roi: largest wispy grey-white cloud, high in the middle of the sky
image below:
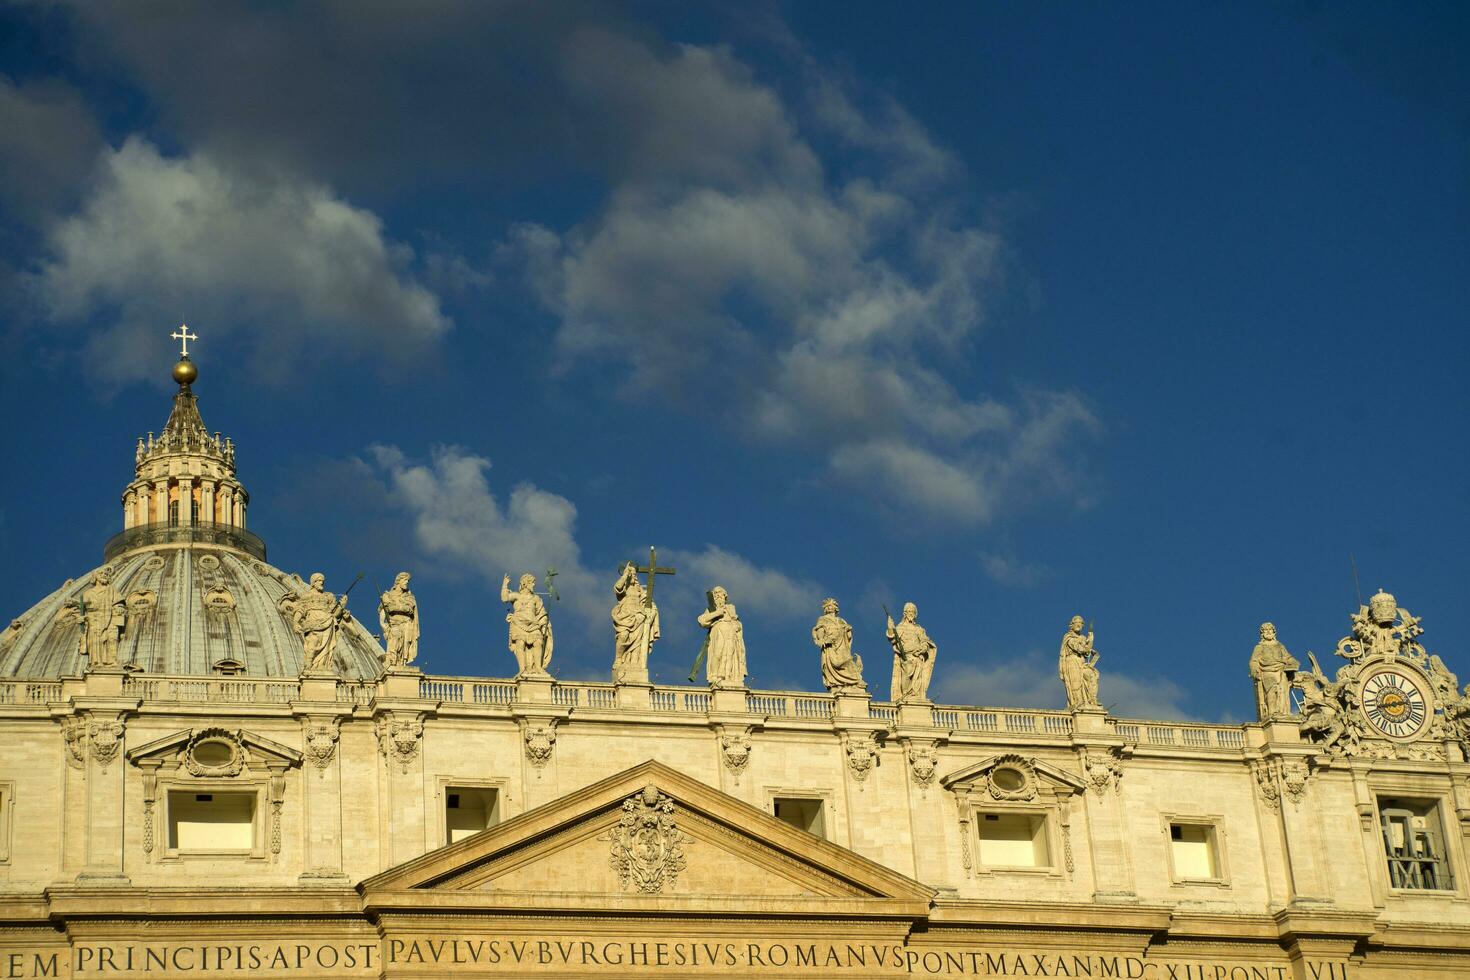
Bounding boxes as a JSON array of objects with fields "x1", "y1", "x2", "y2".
[{"x1": 512, "y1": 32, "x2": 1098, "y2": 523}]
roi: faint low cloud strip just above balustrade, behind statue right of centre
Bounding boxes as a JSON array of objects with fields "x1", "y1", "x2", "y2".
[{"x1": 931, "y1": 652, "x2": 1200, "y2": 721}]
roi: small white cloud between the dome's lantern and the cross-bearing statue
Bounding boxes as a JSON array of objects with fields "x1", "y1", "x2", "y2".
[{"x1": 368, "y1": 445, "x2": 602, "y2": 630}]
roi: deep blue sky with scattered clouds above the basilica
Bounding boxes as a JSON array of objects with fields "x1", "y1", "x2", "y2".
[{"x1": 0, "y1": 3, "x2": 1470, "y2": 720}]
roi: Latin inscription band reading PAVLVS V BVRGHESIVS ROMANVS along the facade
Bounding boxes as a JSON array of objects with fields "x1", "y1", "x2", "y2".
[{"x1": 0, "y1": 937, "x2": 1352, "y2": 980}]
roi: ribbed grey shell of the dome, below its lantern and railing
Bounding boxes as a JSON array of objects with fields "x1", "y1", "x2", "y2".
[{"x1": 0, "y1": 545, "x2": 382, "y2": 680}]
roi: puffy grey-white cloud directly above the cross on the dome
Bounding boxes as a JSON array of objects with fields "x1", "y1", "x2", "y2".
[{"x1": 38, "y1": 137, "x2": 450, "y2": 378}]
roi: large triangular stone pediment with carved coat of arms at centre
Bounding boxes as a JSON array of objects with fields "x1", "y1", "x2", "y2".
[{"x1": 360, "y1": 761, "x2": 935, "y2": 912}]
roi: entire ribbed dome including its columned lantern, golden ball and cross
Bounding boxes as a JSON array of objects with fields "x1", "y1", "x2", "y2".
[{"x1": 0, "y1": 343, "x2": 384, "y2": 680}]
